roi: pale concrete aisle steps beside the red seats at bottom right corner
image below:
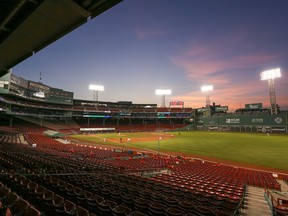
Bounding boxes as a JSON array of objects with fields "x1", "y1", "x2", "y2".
[{"x1": 241, "y1": 186, "x2": 272, "y2": 216}]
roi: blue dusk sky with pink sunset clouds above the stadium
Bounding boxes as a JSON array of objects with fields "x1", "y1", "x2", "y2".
[{"x1": 12, "y1": 0, "x2": 288, "y2": 112}]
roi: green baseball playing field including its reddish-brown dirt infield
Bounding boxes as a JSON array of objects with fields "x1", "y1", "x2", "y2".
[{"x1": 73, "y1": 132, "x2": 288, "y2": 171}]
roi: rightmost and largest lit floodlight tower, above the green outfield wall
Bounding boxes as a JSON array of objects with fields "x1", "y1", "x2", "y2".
[{"x1": 260, "y1": 68, "x2": 281, "y2": 115}]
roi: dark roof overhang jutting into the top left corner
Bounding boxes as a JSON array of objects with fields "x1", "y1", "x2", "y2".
[{"x1": 0, "y1": 0, "x2": 122, "y2": 77}]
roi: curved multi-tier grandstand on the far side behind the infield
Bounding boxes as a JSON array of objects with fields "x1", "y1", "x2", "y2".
[{"x1": 0, "y1": 73, "x2": 194, "y2": 133}]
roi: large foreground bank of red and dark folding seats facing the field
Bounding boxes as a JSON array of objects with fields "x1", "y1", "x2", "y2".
[{"x1": 0, "y1": 131, "x2": 287, "y2": 216}]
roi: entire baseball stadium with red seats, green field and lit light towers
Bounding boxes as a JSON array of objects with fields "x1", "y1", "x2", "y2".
[{"x1": 0, "y1": 0, "x2": 288, "y2": 216}]
